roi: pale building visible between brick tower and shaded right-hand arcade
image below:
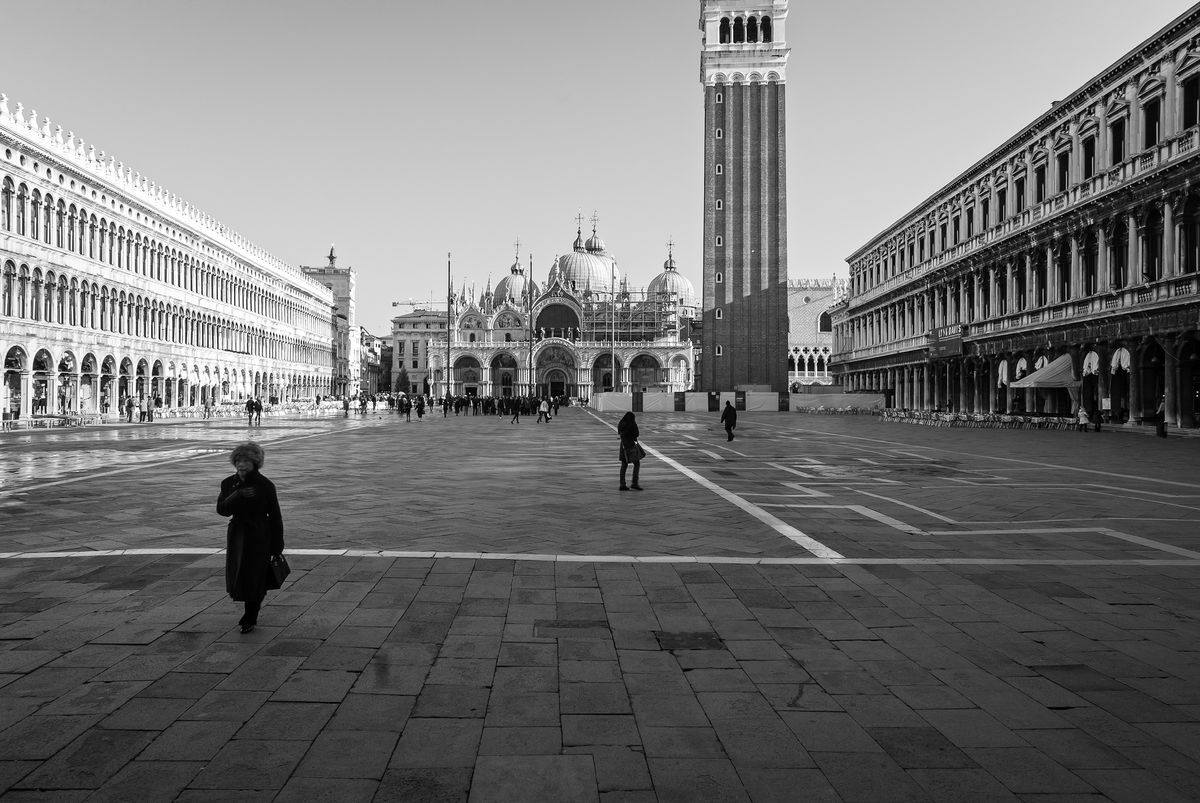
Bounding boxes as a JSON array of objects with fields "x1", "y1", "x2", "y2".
[{"x1": 787, "y1": 278, "x2": 846, "y2": 392}]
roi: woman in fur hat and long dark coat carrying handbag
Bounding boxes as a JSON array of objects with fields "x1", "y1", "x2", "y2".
[{"x1": 217, "y1": 443, "x2": 283, "y2": 633}]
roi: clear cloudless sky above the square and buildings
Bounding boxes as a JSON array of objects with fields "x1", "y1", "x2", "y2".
[{"x1": 0, "y1": 0, "x2": 1190, "y2": 335}]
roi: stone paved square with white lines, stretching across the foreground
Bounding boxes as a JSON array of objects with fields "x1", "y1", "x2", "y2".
[{"x1": 0, "y1": 408, "x2": 1200, "y2": 801}]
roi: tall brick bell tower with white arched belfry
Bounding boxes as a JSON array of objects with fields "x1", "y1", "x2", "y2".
[{"x1": 700, "y1": 0, "x2": 791, "y2": 391}]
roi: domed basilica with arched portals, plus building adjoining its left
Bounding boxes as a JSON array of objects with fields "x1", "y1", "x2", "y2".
[{"x1": 392, "y1": 224, "x2": 696, "y2": 397}]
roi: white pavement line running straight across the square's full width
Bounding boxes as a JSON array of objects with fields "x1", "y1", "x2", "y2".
[{"x1": 0, "y1": 547, "x2": 1200, "y2": 569}]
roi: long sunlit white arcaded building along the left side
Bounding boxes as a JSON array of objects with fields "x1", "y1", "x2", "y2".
[{"x1": 0, "y1": 95, "x2": 332, "y2": 418}]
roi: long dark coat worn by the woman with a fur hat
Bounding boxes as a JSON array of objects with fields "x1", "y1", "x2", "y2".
[{"x1": 217, "y1": 472, "x2": 283, "y2": 603}]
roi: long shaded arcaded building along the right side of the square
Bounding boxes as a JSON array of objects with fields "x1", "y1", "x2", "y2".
[{"x1": 834, "y1": 8, "x2": 1200, "y2": 427}]
